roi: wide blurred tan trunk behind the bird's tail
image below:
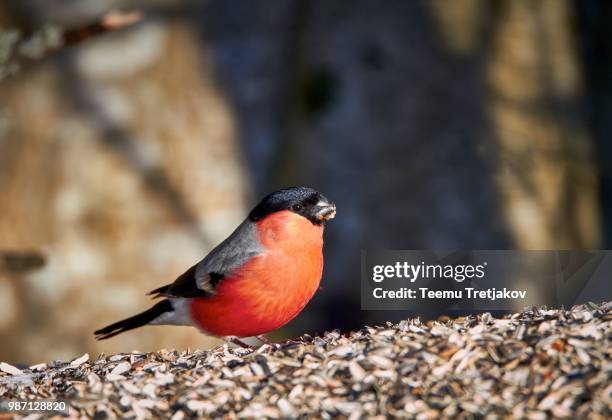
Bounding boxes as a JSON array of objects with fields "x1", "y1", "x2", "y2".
[{"x1": 0, "y1": 1, "x2": 249, "y2": 363}]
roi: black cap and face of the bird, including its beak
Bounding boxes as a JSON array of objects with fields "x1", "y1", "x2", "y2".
[{"x1": 249, "y1": 187, "x2": 336, "y2": 225}]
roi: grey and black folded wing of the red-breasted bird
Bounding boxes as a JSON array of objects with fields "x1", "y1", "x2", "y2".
[{"x1": 149, "y1": 219, "x2": 263, "y2": 298}]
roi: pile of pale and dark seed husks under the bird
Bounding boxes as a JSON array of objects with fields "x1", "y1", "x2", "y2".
[{"x1": 0, "y1": 303, "x2": 612, "y2": 419}]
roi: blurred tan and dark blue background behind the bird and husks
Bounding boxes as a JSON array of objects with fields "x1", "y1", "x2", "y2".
[{"x1": 0, "y1": 0, "x2": 612, "y2": 363}]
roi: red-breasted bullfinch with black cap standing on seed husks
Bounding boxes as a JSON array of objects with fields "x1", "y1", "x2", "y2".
[{"x1": 94, "y1": 187, "x2": 336, "y2": 347}]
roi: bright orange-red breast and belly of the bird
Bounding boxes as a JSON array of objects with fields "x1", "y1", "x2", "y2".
[{"x1": 191, "y1": 211, "x2": 323, "y2": 337}]
